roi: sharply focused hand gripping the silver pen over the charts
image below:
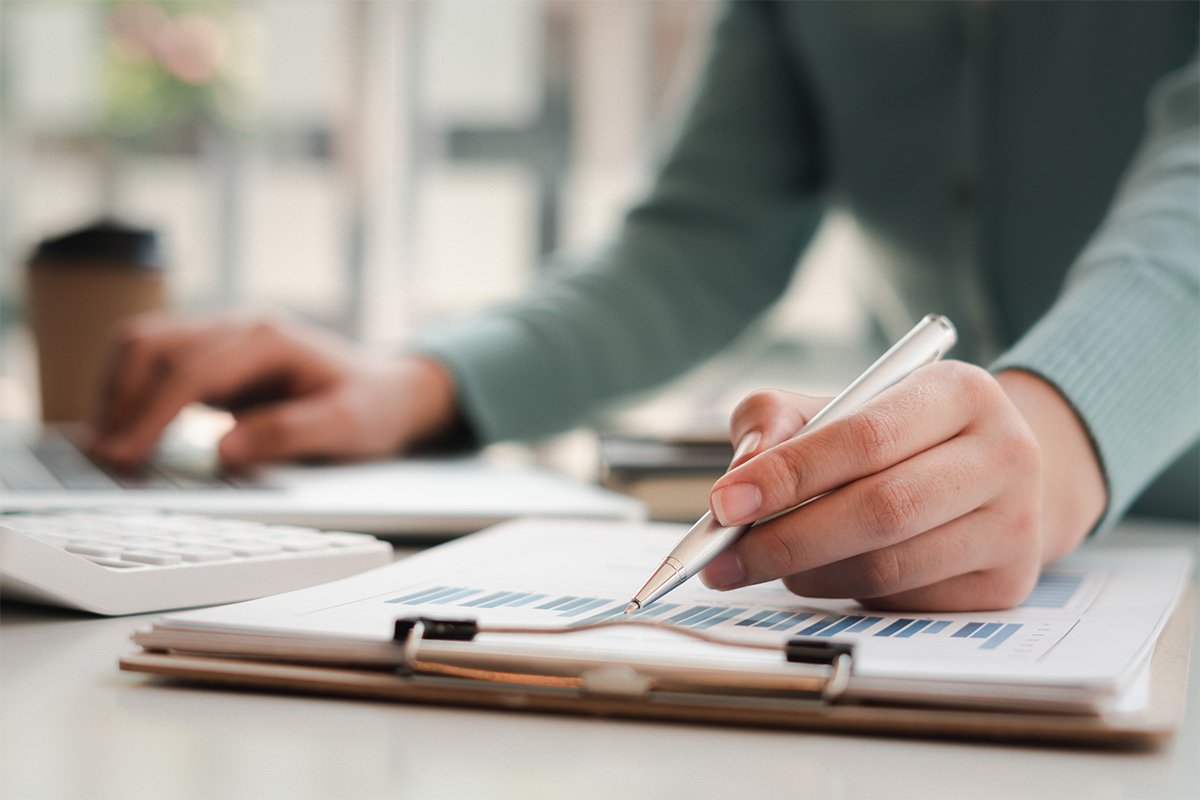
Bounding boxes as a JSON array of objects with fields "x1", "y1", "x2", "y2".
[{"x1": 702, "y1": 361, "x2": 1106, "y2": 610}]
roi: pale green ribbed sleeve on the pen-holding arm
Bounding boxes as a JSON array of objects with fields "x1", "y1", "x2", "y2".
[{"x1": 992, "y1": 53, "x2": 1200, "y2": 530}]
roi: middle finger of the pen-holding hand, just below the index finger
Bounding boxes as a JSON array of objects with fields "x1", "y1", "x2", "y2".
[{"x1": 706, "y1": 437, "x2": 1010, "y2": 596}]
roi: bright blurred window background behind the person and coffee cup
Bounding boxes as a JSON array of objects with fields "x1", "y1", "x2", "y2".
[{"x1": 0, "y1": 0, "x2": 865, "y2": 424}]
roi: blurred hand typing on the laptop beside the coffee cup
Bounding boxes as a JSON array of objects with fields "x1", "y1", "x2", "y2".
[{"x1": 91, "y1": 315, "x2": 457, "y2": 467}]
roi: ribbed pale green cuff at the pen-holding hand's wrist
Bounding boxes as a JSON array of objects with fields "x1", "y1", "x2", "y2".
[{"x1": 991, "y1": 259, "x2": 1200, "y2": 534}]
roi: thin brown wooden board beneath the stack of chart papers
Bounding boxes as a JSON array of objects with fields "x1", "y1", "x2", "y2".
[{"x1": 120, "y1": 588, "x2": 1195, "y2": 748}]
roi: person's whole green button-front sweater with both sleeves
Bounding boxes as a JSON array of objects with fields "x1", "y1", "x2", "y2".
[{"x1": 419, "y1": 0, "x2": 1200, "y2": 532}]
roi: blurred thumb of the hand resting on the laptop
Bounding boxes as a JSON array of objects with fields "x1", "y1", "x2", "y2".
[{"x1": 220, "y1": 392, "x2": 357, "y2": 467}]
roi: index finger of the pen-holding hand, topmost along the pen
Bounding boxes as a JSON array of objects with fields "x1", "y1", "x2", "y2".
[{"x1": 709, "y1": 362, "x2": 1007, "y2": 525}]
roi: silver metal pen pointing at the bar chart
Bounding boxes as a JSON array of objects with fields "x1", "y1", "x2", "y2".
[{"x1": 625, "y1": 314, "x2": 958, "y2": 614}]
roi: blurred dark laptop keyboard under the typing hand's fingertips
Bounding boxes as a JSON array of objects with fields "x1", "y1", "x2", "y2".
[{"x1": 0, "y1": 428, "x2": 244, "y2": 492}]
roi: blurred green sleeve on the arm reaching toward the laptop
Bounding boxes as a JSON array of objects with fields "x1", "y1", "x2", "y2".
[{"x1": 416, "y1": 1, "x2": 820, "y2": 443}]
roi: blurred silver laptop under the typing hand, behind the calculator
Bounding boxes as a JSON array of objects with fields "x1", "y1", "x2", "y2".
[{"x1": 0, "y1": 422, "x2": 644, "y2": 539}]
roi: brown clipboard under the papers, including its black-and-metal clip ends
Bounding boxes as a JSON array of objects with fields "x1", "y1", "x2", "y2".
[{"x1": 120, "y1": 587, "x2": 1195, "y2": 748}]
